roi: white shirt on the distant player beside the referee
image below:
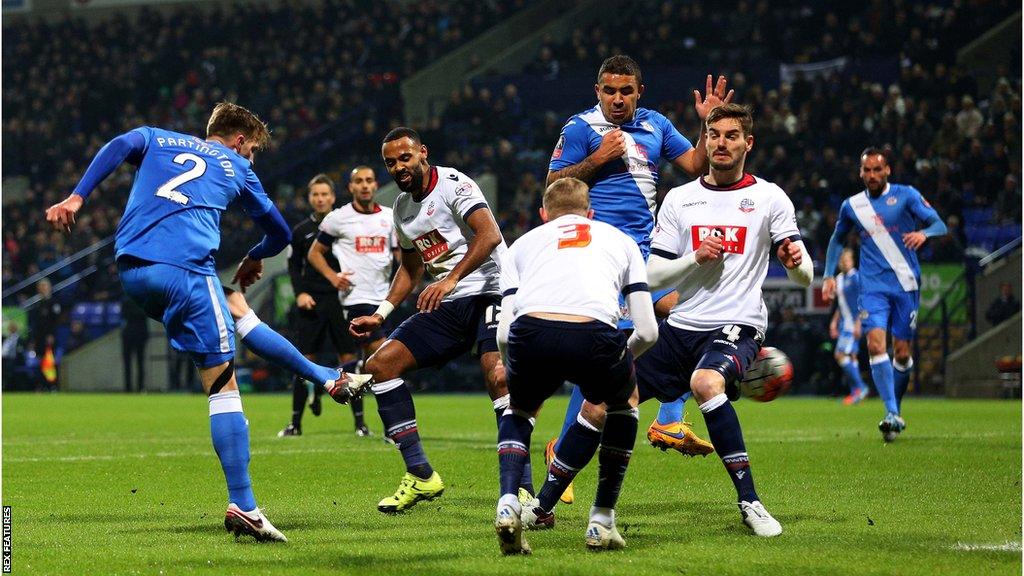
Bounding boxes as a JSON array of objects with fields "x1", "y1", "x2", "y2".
[{"x1": 317, "y1": 203, "x2": 398, "y2": 306}]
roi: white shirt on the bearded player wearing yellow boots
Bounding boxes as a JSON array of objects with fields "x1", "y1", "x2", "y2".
[{"x1": 394, "y1": 166, "x2": 506, "y2": 301}]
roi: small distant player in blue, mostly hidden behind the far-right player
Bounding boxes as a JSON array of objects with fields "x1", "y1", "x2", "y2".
[{"x1": 828, "y1": 248, "x2": 867, "y2": 406}]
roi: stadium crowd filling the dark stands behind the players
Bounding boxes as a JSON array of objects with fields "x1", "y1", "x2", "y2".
[{"x1": 2, "y1": 0, "x2": 1021, "y2": 373}]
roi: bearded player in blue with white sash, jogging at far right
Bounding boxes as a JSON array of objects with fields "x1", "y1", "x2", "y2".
[{"x1": 821, "y1": 148, "x2": 946, "y2": 442}]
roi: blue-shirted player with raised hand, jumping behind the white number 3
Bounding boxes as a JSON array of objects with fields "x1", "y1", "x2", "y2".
[{"x1": 547, "y1": 55, "x2": 733, "y2": 503}]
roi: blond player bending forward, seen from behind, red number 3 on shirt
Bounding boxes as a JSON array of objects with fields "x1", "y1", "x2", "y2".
[{"x1": 495, "y1": 177, "x2": 657, "y2": 554}]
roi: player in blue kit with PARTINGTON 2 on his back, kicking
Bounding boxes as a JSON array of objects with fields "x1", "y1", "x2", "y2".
[{"x1": 46, "y1": 102, "x2": 370, "y2": 541}]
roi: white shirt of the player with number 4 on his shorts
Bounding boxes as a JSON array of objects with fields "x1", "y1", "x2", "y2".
[{"x1": 651, "y1": 174, "x2": 800, "y2": 332}]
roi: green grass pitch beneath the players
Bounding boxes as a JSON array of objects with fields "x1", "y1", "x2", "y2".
[{"x1": 3, "y1": 394, "x2": 1021, "y2": 576}]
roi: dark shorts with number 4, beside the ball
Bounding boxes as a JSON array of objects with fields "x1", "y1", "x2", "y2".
[{"x1": 636, "y1": 322, "x2": 761, "y2": 402}]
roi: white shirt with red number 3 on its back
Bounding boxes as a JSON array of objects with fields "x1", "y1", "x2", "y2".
[{"x1": 501, "y1": 214, "x2": 647, "y2": 327}]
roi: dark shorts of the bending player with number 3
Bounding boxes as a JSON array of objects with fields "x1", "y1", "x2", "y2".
[{"x1": 505, "y1": 316, "x2": 636, "y2": 412}]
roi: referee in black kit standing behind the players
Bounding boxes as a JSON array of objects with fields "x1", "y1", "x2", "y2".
[{"x1": 278, "y1": 174, "x2": 370, "y2": 438}]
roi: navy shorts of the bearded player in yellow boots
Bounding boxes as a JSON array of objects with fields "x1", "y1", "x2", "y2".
[{"x1": 390, "y1": 294, "x2": 502, "y2": 368}]
